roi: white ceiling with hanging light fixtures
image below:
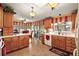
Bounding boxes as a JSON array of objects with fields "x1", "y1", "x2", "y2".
[{"x1": 3, "y1": 3, "x2": 78, "y2": 21}]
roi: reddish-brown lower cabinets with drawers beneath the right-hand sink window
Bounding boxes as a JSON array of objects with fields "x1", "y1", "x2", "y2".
[{"x1": 52, "y1": 35, "x2": 76, "y2": 53}]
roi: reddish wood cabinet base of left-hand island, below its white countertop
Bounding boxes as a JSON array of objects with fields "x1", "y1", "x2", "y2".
[{"x1": 3, "y1": 35, "x2": 29, "y2": 53}]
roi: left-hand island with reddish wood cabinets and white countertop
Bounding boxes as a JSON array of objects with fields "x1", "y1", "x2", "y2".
[{"x1": 0, "y1": 33, "x2": 31, "y2": 55}]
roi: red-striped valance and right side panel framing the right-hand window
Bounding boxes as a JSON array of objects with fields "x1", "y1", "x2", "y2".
[{"x1": 52, "y1": 13, "x2": 77, "y2": 31}]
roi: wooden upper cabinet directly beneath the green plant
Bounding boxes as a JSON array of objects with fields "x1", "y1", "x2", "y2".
[{"x1": 3, "y1": 12, "x2": 13, "y2": 27}]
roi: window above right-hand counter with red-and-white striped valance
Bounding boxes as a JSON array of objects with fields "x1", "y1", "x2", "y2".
[{"x1": 54, "y1": 14, "x2": 76, "y2": 31}]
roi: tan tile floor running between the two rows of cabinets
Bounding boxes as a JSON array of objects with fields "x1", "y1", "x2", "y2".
[{"x1": 7, "y1": 40, "x2": 58, "y2": 56}]
